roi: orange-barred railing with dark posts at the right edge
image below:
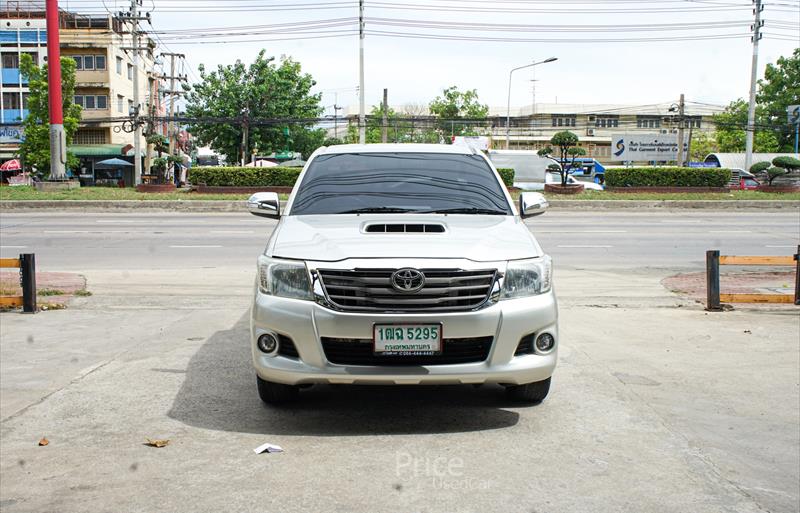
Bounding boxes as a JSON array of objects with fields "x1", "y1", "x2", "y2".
[{"x1": 706, "y1": 246, "x2": 800, "y2": 312}]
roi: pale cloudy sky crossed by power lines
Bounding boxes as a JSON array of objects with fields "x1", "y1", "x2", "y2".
[{"x1": 54, "y1": 0, "x2": 800, "y2": 114}]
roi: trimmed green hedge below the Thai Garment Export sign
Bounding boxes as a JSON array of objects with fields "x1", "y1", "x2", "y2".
[{"x1": 606, "y1": 167, "x2": 731, "y2": 187}]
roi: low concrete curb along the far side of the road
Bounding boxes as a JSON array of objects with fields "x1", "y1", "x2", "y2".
[{"x1": 0, "y1": 199, "x2": 800, "y2": 212}]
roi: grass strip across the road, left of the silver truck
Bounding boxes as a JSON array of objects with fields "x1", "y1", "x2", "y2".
[{"x1": 0, "y1": 186, "x2": 289, "y2": 201}]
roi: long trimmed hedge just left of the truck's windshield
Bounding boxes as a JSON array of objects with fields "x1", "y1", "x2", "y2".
[{"x1": 189, "y1": 167, "x2": 302, "y2": 187}]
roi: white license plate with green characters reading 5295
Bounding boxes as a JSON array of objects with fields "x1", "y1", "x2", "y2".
[{"x1": 372, "y1": 324, "x2": 442, "y2": 356}]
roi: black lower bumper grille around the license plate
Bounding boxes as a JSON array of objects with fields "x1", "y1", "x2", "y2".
[{"x1": 322, "y1": 336, "x2": 494, "y2": 366}]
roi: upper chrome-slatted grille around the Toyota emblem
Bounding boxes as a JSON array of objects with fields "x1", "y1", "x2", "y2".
[{"x1": 317, "y1": 269, "x2": 497, "y2": 312}]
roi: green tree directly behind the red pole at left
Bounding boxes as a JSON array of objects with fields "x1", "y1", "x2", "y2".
[{"x1": 19, "y1": 53, "x2": 81, "y2": 178}]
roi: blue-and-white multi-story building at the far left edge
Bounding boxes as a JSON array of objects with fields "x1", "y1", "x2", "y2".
[{"x1": 0, "y1": 12, "x2": 47, "y2": 162}]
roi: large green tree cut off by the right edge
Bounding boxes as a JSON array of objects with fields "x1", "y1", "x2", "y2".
[{"x1": 756, "y1": 48, "x2": 800, "y2": 153}]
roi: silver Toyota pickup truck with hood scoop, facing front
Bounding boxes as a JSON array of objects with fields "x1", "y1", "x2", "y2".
[{"x1": 247, "y1": 144, "x2": 558, "y2": 403}]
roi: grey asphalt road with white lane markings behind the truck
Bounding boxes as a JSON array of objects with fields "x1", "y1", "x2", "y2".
[{"x1": 0, "y1": 210, "x2": 800, "y2": 270}]
